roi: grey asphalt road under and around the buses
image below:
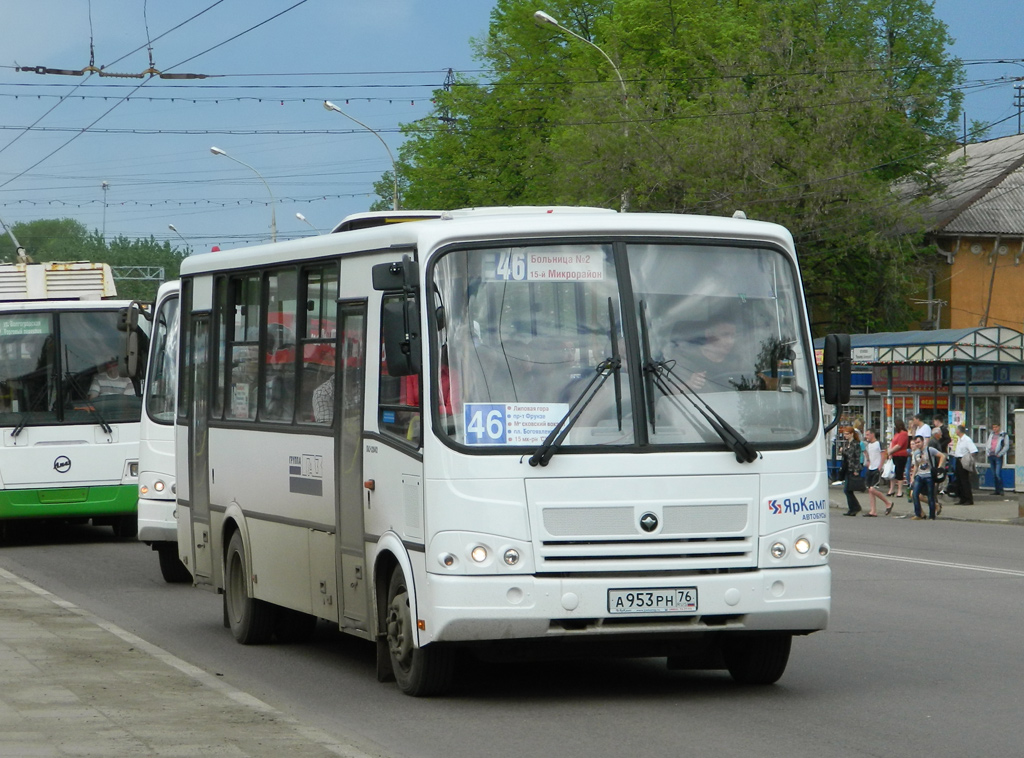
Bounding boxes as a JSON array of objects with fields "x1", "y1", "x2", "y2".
[{"x1": 0, "y1": 518, "x2": 1024, "y2": 758}]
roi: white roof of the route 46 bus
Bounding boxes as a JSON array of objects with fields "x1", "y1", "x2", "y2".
[{"x1": 181, "y1": 208, "x2": 794, "y2": 277}]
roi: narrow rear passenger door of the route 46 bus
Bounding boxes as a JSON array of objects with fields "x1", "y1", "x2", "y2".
[{"x1": 188, "y1": 313, "x2": 213, "y2": 585}]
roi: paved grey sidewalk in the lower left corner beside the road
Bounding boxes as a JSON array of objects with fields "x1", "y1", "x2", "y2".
[{"x1": 0, "y1": 569, "x2": 369, "y2": 758}]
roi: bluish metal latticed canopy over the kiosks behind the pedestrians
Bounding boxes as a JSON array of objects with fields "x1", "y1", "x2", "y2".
[{"x1": 814, "y1": 327, "x2": 1024, "y2": 366}]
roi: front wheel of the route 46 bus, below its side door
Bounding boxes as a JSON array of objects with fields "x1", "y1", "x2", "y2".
[{"x1": 385, "y1": 569, "x2": 455, "y2": 698}]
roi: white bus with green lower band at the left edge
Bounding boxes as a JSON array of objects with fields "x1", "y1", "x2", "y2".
[{"x1": 0, "y1": 263, "x2": 144, "y2": 538}]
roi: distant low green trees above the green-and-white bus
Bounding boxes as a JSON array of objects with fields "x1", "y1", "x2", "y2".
[{"x1": 0, "y1": 218, "x2": 186, "y2": 302}]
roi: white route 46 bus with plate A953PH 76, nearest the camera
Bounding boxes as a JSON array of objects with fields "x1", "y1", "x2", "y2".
[{"x1": 176, "y1": 208, "x2": 840, "y2": 696}]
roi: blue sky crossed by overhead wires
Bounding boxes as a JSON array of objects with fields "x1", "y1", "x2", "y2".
[{"x1": 0, "y1": 0, "x2": 1024, "y2": 253}]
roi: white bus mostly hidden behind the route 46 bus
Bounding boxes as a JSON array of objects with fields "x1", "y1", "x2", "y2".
[{"x1": 138, "y1": 282, "x2": 191, "y2": 583}]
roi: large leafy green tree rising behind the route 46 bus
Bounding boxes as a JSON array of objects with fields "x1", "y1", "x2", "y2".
[{"x1": 381, "y1": 0, "x2": 963, "y2": 331}]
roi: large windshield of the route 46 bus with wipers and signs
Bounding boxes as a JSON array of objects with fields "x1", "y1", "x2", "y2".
[{"x1": 432, "y1": 240, "x2": 816, "y2": 449}]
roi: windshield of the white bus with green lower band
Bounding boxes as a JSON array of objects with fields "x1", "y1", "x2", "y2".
[{"x1": 0, "y1": 309, "x2": 141, "y2": 430}]
